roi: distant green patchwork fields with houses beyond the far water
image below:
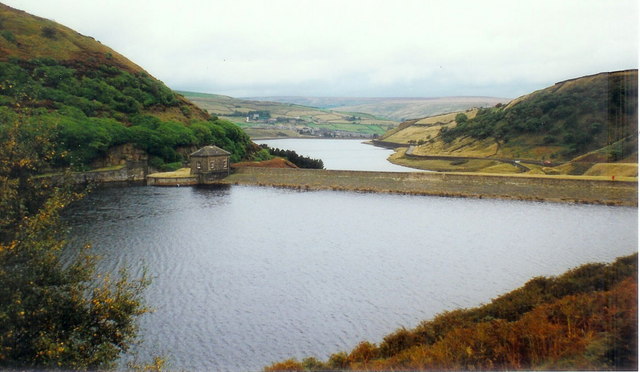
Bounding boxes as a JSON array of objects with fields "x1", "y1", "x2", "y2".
[{"x1": 178, "y1": 91, "x2": 398, "y2": 138}]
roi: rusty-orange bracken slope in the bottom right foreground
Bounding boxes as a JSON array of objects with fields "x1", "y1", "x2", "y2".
[{"x1": 265, "y1": 254, "x2": 638, "y2": 371}]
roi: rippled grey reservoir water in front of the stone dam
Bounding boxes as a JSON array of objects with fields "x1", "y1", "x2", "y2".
[{"x1": 61, "y1": 139, "x2": 638, "y2": 371}]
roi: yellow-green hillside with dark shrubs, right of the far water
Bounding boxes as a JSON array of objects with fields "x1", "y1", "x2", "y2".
[{"x1": 381, "y1": 70, "x2": 638, "y2": 177}]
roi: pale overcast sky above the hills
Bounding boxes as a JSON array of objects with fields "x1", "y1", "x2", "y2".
[{"x1": 5, "y1": 0, "x2": 638, "y2": 98}]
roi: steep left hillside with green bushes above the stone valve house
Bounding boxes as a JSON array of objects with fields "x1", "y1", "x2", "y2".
[{"x1": 0, "y1": 4, "x2": 256, "y2": 171}]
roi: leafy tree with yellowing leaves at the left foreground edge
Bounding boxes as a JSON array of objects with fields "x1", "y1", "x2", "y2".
[{"x1": 0, "y1": 110, "x2": 148, "y2": 369}]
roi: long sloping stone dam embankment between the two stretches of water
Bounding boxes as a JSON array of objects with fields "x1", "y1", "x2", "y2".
[{"x1": 219, "y1": 168, "x2": 638, "y2": 206}]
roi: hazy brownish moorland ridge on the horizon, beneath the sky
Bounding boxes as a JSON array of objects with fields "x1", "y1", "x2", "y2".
[{"x1": 242, "y1": 97, "x2": 509, "y2": 121}]
